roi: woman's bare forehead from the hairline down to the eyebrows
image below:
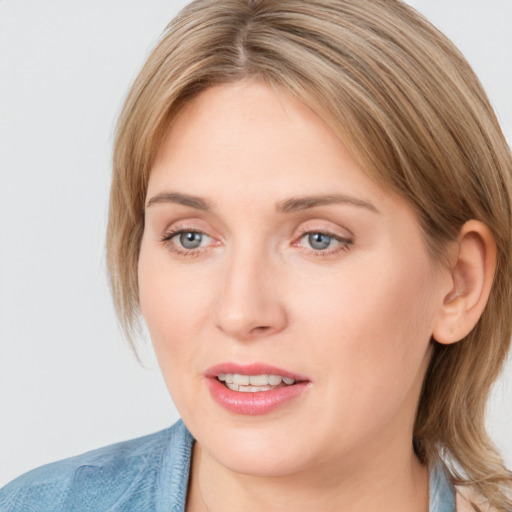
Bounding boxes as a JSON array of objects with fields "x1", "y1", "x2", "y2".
[{"x1": 148, "y1": 80, "x2": 396, "y2": 208}]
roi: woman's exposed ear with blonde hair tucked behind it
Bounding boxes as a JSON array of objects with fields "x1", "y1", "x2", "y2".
[{"x1": 432, "y1": 220, "x2": 496, "y2": 345}]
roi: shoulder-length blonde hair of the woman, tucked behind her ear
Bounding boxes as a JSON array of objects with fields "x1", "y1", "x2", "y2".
[{"x1": 107, "y1": 0, "x2": 512, "y2": 511}]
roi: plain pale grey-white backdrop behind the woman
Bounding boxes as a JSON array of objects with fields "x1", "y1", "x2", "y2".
[{"x1": 0, "y1": 0, "x2": 512, "y2": 486}]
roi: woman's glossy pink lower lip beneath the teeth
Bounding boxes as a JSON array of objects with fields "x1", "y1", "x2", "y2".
[{"x1": 206, "y1": 378, "x2": 309, "y2": 416}]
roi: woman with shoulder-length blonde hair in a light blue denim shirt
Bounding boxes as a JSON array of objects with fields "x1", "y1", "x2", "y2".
[{"x1": 0, "y1": 0, "x2": 512, "y2": 512}]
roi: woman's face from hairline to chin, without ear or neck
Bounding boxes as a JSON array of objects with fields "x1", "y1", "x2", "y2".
[{"x1": 139, "y1": 81, "x2": 447, "y2": 476}]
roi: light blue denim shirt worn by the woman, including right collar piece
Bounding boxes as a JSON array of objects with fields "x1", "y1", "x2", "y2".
[{"x1": 0, "y1": 421, "x2": 455, "y2": 512}]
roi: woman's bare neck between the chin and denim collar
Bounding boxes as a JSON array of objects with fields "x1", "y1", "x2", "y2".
[{"x1": 187, "y1": 436, "x2": 429, "y2": 512}]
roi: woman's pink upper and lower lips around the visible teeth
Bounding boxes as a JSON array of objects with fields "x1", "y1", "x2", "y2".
[{"x1": 205, "y1": 363, "x2": 311, "y2": 416}]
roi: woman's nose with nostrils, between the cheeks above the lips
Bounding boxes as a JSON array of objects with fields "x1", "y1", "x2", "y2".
[{"x1": 215, "y1": 248, "x2": 288, "y2": 340}]
